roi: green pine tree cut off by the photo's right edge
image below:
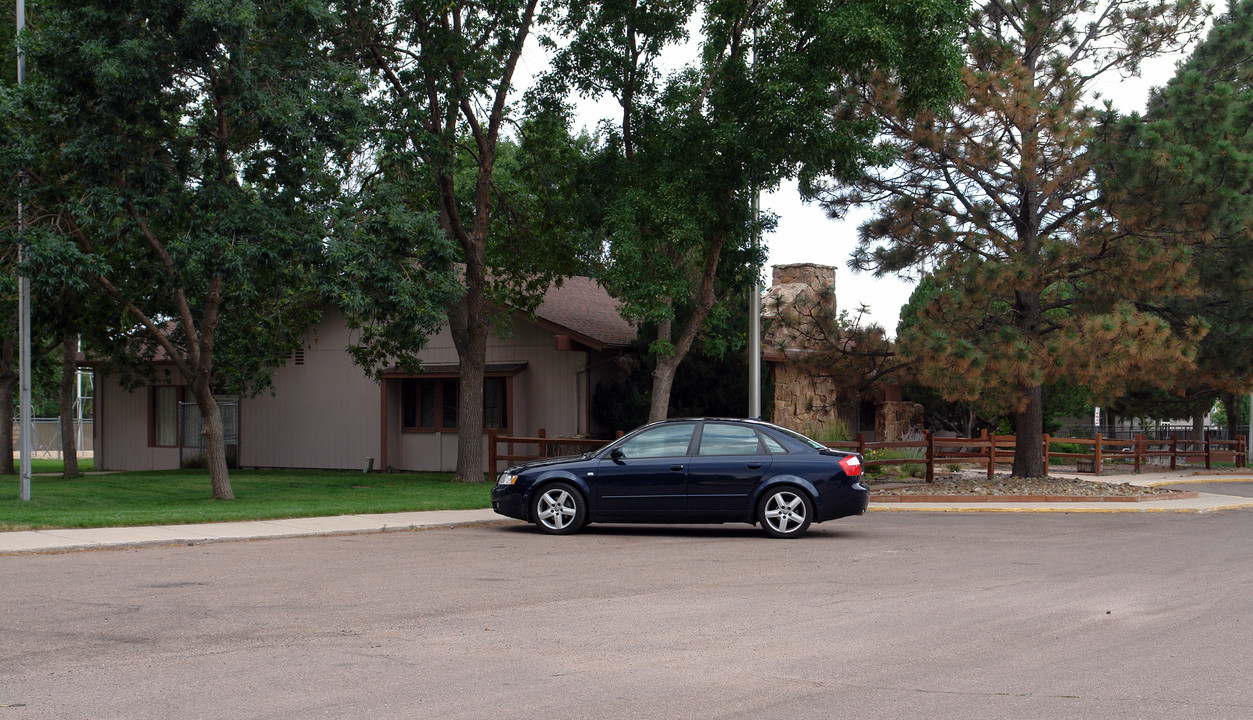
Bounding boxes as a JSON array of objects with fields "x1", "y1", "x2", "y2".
[{"x1": 1095, "y1": 0, "x2": 1253, "y2": 416}]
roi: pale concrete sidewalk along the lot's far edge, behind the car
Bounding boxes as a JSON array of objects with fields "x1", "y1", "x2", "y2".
[{"x1": 0, "y1": 472, "x2": 1253, "y2": 555}]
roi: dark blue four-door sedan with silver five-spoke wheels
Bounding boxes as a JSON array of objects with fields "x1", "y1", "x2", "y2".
[{"x1": 491, "y1": 418, "x2": 870, "y2": 537}]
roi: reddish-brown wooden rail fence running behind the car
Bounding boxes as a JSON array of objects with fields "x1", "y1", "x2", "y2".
[{"x1": 487, "y1": 428, "x2": 1248, "y2": 482}]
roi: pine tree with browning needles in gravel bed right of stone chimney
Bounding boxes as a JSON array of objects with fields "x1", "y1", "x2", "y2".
[{"x1": 809, "y1": 0, "x2": 1204, "y2": 477}]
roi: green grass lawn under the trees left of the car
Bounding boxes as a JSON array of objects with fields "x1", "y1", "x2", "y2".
[{"x1": 0, "y1": 470, "x2": 491, "y2": 531}]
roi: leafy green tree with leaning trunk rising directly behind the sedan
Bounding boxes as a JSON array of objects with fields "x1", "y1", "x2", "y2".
[{"x1": 540, "y1": 0, "x2": 962, "y2": 418}]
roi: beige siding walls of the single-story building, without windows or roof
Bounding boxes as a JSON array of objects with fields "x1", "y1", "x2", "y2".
[{"x1": 98, "y1": 311, "x2": 588, "y2": 471}]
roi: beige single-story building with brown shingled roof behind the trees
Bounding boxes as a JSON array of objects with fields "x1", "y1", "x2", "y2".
[{"x1": 87, "y1": 277, "x2": 635, "y2": 471}]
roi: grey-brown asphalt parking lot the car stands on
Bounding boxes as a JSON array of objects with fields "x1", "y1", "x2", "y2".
[{"x1": 0, "y1": 510, "x2": 1253, "y2": 720}]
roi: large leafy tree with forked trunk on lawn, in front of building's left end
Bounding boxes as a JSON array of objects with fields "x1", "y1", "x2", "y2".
[{"x1": 4, "y1": 0, "x2": 362, "y2": 500}]
